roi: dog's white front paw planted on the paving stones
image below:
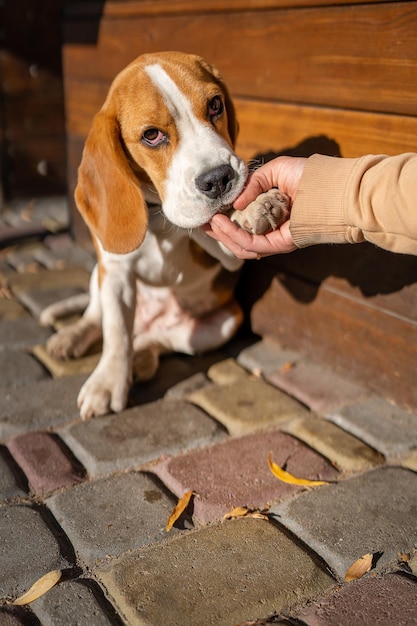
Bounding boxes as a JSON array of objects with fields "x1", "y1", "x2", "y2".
[{"x1": 78, "y1": 367, "x2": 130, "y2": 420}]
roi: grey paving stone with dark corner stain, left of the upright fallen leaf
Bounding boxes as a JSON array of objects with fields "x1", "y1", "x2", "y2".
[{"x1": 46, "y1": 472, "x2": 180, "y2": 565}]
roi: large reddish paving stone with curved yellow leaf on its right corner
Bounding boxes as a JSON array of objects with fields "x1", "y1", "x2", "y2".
[{"x1": 150, "y1": 431, "x2": 339, "y2": 523}]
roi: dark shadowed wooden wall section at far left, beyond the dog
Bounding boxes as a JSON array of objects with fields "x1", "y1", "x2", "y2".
[{"x1": 0, "y1": 0, "x2": 86, "y2": 199}]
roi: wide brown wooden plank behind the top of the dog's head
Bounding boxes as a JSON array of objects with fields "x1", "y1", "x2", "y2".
[{"x1": 65, "y1": 2, "x2": 417, "y2": 115}]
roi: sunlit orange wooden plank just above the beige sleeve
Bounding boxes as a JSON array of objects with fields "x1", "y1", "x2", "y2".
[{"x1": 234, "y1": 98, "x2": 417, "y2": 159}]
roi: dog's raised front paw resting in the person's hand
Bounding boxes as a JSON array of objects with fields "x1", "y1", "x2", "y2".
[{"x1": 230, "y1": 189, "x2": 290, "y2": 235}]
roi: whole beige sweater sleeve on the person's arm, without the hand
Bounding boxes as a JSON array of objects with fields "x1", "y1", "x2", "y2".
[{"x1": 290, "y1": 153, "x2": 417, "y2": 255}]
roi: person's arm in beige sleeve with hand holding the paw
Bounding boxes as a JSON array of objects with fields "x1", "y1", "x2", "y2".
[{"x1": 203, "y1": 153, "x2": 417, "y2": 259}]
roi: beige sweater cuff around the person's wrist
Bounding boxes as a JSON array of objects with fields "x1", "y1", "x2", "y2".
[{"x1": 290, "y1": 154, "x2": 361, "y2": 248}]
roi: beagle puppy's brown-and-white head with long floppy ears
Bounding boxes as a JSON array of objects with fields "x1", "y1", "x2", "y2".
[{"x1": 75, "y1": 52, "x2": 247, "y2": 254}]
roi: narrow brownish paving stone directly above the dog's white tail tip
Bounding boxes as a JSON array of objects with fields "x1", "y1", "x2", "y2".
[{"x1": 9, "y1": 268, "x2": 90, "y2": 296}]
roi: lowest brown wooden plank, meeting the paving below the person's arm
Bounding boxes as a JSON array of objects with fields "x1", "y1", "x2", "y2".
[{"x1": 252, "y1": 275, "x2": 417, "y2": 410}]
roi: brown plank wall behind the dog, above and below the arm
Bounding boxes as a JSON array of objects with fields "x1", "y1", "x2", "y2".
[{"x1": 63, "y1": 0, "x2": 417, "y2": 408}]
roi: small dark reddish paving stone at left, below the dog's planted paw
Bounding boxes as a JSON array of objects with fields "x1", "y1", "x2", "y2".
[{"x1": 7, "y1": 432, "x2": 83, "y2": 496}]
